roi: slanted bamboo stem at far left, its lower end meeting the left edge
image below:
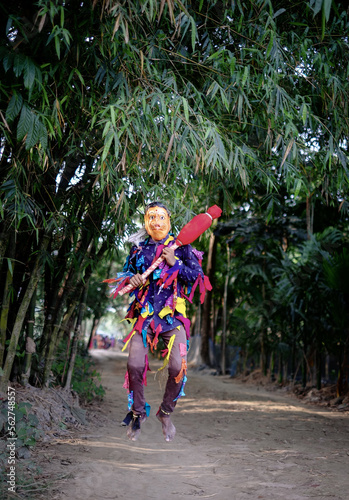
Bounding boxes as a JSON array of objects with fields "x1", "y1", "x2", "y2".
[{"x1": 1, "y1": 234, "x2": 51, "y2": 391}]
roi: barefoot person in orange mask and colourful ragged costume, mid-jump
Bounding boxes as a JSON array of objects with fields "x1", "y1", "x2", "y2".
[{"x1": 110, "y1": 202, "x2": 211, "y2": 441}]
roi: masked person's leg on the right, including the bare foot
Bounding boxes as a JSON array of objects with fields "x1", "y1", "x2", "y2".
[{"x1": 157, "y1": 327, "x2": 187, "y2": 441}]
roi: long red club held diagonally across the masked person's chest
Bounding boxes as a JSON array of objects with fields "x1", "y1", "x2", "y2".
[{"x1": 119, "y1": 205, "x2": 222, "y2": 295}]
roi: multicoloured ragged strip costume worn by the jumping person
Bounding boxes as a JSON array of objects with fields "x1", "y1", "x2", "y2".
[{"x1": 110, "y1": 233, "x2": 211, "y2": 425}]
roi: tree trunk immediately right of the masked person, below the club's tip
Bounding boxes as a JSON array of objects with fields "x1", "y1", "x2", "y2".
[{"x1": 200, "y1": 233, "x2": 217, "y2": 366}]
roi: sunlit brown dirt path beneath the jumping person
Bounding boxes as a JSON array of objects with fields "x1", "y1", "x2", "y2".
[{"x1": 42, "y1": 351, "x2": 349, "y2": 500}]
